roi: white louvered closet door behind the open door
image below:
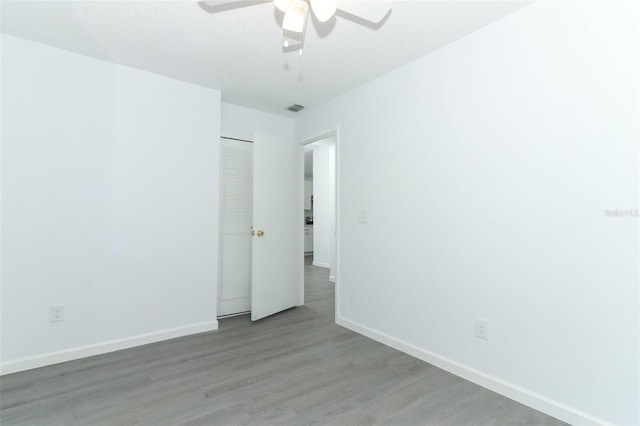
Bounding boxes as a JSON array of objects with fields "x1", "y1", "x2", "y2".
[{"x1": 218, "y1": 139, "x2": 253, "y2": 316}]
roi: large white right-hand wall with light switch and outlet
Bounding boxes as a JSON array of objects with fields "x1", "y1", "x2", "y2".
[{"x1": 296, "y1": 2, "x2": 640, "y2": 425}]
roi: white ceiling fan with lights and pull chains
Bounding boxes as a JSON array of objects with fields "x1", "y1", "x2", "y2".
[{"x1": 201, "y1": 0, "x2": 391, "y2": 55}]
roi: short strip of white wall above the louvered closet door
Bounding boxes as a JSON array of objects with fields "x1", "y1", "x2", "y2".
[{"x1": 220, "y1": 102, "x2": 295, "y2": 141}]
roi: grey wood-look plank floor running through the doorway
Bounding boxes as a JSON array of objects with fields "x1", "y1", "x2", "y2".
[{"x1": 0, "y1": 262, "x2": 564, "y2": 426}]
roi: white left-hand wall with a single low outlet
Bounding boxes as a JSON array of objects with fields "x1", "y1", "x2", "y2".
[{"x1": 1, "y1": 35, "x2": 220, "y2": 372}]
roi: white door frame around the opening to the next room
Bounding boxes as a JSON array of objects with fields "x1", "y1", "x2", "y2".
[{"x1": 298, "y1": 125, "x2": 341, "y2": 320}]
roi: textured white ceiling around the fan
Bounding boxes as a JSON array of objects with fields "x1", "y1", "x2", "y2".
[{"x1": 1, "y1": 0, "x2": 527, "y2": 115}]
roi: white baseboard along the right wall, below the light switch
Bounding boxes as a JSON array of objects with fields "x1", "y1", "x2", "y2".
[{"x1": 336, "y1": 317, "x2": 610, "y2": 425}]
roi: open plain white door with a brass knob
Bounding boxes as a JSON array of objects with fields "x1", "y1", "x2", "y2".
[{"x1": 251, "y1": 132, "x2": 302, "y2": 321}]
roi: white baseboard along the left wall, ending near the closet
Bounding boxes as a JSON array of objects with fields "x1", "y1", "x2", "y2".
[{"x1": 0, "y1": 320, "x2": 218, "y2": 375}]
